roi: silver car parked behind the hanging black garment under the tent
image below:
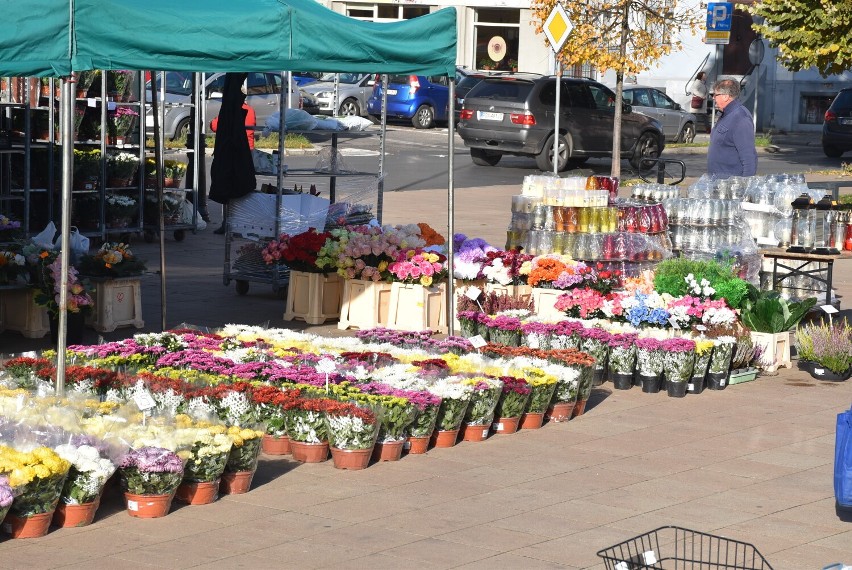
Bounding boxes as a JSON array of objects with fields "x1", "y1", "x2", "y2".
[{"x1": 145, "y1": 71, "x2": 302, "y2": 139}]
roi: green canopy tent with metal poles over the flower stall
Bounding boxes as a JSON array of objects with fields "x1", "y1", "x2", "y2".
[{"x1": 0, "y1": 0, "x2": 456, "y2": 392}]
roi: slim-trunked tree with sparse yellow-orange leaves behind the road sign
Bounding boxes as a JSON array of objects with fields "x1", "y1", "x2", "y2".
[{"x1": 531, "y1": 0, "x2": 704, "y2": 176}]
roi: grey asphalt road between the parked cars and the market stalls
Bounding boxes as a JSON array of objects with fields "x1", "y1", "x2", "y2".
[{"x1": 276, "y1": 125, "x2": 843, "y2": 191}]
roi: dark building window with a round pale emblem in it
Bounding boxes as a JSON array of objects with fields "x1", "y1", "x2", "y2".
[{"x1": 474, "y1": 8, "x2": 521, "y2": 71}]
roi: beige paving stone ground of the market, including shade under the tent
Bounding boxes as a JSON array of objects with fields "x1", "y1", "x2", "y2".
[{"x1": 0, "y1": 174, "x2": 852, "y2": 570}]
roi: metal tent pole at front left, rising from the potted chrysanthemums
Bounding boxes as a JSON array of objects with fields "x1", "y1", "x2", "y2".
[{"x1": 56, "y1": 77, "x2": 76, "y2": 396}]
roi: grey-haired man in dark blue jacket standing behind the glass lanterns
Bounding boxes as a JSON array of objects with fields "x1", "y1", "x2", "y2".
[{"x1": 707, "y1": 79, "x2": 757, "y2": 178}]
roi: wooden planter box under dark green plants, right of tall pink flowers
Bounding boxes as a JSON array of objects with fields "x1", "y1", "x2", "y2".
[{"x1": 86, "y1": 277, "x2": 145, "y2": 332}]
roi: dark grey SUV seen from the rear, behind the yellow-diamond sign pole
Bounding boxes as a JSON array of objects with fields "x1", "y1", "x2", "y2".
[{"x1": 458, "y1": 74, "x2": 665, "y2": 171}]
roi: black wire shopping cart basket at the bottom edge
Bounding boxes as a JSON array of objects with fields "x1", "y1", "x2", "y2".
[{"x1": 598, "y1": 526, "x2": 772, "y2": 570}]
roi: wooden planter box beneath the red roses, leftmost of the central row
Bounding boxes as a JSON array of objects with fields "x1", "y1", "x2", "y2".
[{"x1": 284, "y1": 271, "x2": 343, "y2": 325}]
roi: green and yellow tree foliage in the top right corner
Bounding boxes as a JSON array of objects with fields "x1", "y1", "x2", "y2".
[{"x1": 751, "y1": 0, "x2": 852, "y2": 77}]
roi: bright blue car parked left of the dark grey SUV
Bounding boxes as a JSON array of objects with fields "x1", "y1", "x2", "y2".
[{"x1": 367, "y1": 75, "x2": 450, "y2": 129}]
